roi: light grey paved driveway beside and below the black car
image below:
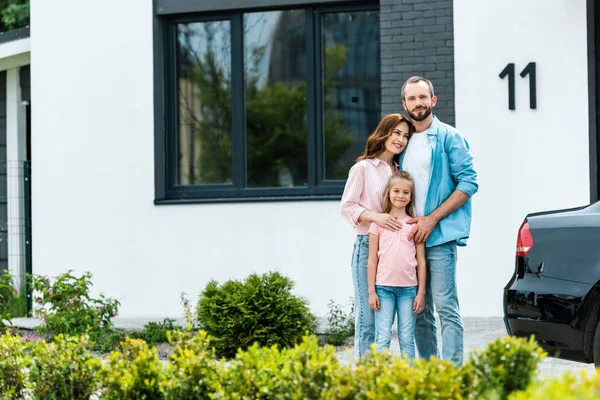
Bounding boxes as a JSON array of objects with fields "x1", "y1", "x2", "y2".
[{"x1": 337, "y1": 318, "x2": 594, "y2": 378}]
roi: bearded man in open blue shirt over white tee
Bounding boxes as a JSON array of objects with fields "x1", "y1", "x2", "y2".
[{"x1": 400, "y1": 76, "x2": 478, "y2": 364}]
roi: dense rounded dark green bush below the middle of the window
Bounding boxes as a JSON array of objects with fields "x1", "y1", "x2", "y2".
[{"x1": 197, "y1": 272, "x2": 316, "y2": 357}]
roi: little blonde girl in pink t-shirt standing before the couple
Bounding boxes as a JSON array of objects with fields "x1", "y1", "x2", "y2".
[{"x1": 368, "y1": 171, "x2": 427, "y2": 359}]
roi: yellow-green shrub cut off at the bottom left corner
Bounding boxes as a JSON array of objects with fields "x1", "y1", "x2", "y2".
[{"x1": 0, "y1": 332, "x2": 31, "y2": 399}]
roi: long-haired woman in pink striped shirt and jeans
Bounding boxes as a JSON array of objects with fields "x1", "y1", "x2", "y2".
[{"x1": 341, "y1": 114, "x2": 414, "y2": 358}]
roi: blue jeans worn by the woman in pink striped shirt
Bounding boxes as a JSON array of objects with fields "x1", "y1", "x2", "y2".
[{"x1": 352, "y1": 235, "x2": 375, "y2": 359}]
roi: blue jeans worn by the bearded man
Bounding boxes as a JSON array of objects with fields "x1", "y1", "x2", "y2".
[{"x1": 415, "y1": 242, "x2": 464, "y2": 365}]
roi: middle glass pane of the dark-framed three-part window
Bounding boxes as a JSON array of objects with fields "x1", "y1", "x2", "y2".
[{"x1": 244, "y1": 10, "x2": 308, "y2": 187}]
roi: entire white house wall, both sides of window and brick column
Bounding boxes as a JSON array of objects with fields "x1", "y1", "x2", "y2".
[{"x1": 31, "y1": 0, "x2": 589, "y2": 317}]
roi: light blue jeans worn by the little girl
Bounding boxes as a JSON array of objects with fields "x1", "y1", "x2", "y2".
[{"x1": 375, "y1": 285, "x2": 417, "y2": 360}]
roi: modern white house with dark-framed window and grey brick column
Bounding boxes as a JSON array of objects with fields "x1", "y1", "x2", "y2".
[{"x1": 16, "y1": 0, "x2": 600, "y2": 317}]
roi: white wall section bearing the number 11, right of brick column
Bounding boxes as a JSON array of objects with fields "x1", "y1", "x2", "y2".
[{"x1": 454, "y1": 0, "x2": 590, "y2": 315}]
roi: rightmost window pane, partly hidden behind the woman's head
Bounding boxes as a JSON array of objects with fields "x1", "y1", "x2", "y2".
[{"x1": 321, "y1": 11, "x2": 381, "y2": 180}]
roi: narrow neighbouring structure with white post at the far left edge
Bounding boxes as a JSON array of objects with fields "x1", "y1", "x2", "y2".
[{"x1": 0, "y1": 28, "x2": 31, "y2": 304}]
